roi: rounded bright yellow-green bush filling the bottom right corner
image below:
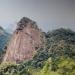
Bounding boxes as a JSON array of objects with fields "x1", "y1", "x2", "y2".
[{"x1": 57, "y1": 57, "x2": 75, "y2": 75}]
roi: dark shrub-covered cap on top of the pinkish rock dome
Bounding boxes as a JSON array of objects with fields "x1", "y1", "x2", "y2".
[{"x1": 16, "y1": 17, "x2": 39, "y2": 30}]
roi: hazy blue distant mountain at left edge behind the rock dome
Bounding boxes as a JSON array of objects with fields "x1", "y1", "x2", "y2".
[{"x1": 0, "y1": 27, "x2": 11, "y2": 61}]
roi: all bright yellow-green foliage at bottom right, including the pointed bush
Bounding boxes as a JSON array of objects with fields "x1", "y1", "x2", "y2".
[{"x1": 36, "y1": 57, "x2": 75, "y2": 75}]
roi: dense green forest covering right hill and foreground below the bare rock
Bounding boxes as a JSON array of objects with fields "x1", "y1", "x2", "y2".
[{"x1": 0, "y1": 28, "x2": 75, "y2": 75}]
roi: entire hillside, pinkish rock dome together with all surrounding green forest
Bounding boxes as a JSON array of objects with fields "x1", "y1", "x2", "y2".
[{"x1": 0, "y1": 17, "x2": 75, "y2": 75}]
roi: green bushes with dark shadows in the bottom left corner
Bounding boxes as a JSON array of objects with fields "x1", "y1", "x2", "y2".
[{"x1": 0, "y1": 63, "x2": 31, "y2": 75}]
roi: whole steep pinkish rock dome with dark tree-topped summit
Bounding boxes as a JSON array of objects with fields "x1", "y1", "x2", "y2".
[{"x1": 4, "y1": 17, "x2": 42, "y2": 62}]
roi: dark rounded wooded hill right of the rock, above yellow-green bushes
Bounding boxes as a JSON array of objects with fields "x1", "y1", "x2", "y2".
[{"x1": 46, "y1": 28, "x2": 75, "y2": 57}]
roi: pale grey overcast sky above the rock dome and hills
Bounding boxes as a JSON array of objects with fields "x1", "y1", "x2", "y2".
[{"x1": 0, "y1": 0, "x2": 75, "y2": 32}]
